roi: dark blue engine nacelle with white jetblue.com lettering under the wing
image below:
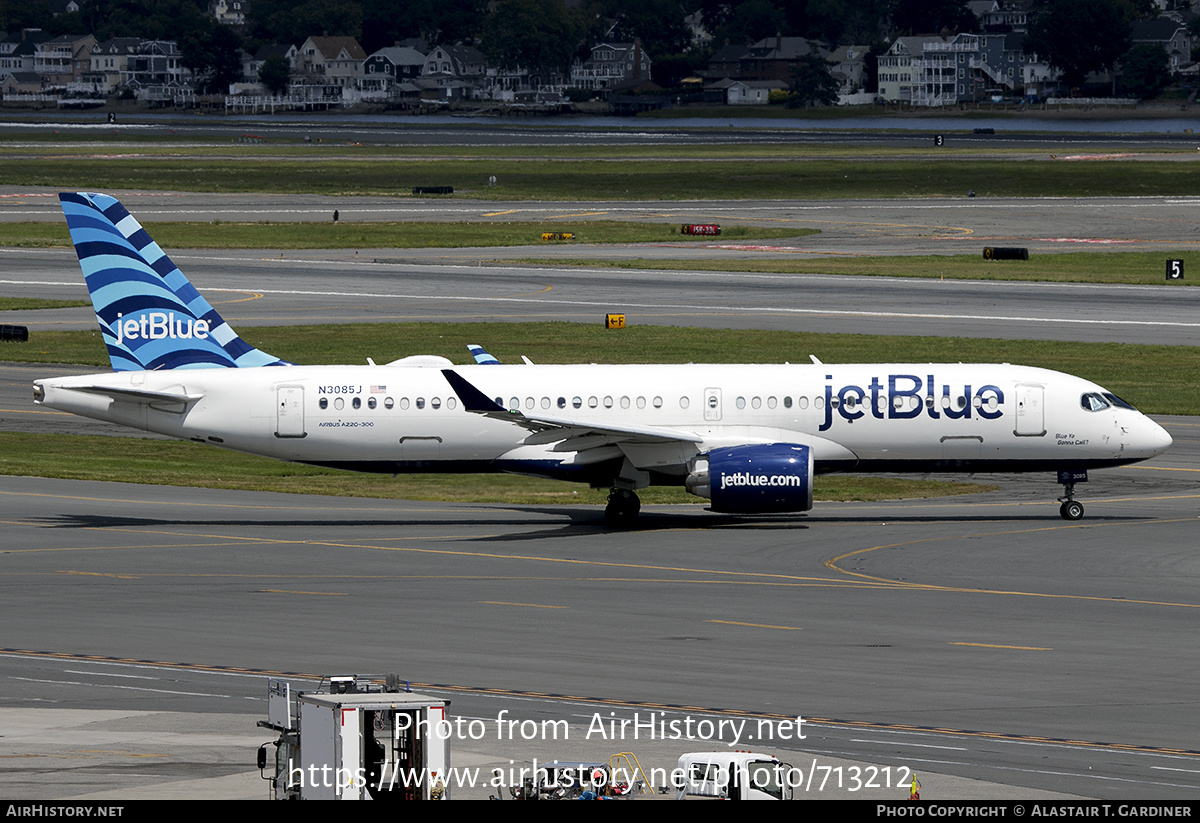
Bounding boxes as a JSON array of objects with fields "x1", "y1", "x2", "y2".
[{"x1": 684, "y1": 443, "x2": 812, "y2": 513}]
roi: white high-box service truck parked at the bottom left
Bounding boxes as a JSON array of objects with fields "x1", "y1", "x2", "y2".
[{"x1": 258, "y1": 675, "x2": 450, "y2": 800}]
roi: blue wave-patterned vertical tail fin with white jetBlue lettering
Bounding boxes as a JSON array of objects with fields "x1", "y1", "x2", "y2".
[{"x1": 59, "y1": 192, "x2": 288, "y2": 372}]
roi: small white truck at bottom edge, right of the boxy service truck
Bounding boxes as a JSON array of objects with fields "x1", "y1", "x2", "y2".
[{"x1": 676, "y1": 751, "x2": 792, "y2": 800}]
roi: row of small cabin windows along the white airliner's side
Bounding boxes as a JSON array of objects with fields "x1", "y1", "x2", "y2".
[{"x1": 317, "y1": 395, "x2": 993, "y2": 412}]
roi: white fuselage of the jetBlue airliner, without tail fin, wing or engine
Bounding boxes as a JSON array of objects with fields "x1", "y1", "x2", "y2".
[{"x1": 37, "y1": 364, "x2": 1170, "y2": 485}]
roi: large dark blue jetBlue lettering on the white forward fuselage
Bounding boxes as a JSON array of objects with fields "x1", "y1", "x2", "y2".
[{"x1": 818, "y1": 374, "x2": 1004, "y2": 432}]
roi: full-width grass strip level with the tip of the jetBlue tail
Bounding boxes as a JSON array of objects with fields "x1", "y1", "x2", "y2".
[{"x1": 5, "y1": 159, "x2": 1200, "y2": 200}]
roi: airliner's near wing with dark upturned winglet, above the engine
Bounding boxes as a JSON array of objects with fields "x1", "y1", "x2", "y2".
[{"x1": 442, "y1": 368, "x2": 703, "y2": 451}]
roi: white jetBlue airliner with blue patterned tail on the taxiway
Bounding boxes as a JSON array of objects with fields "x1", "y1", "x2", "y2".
[{"x1": 34, "y1": 193, "x2": 1171, "y2": 525}]
